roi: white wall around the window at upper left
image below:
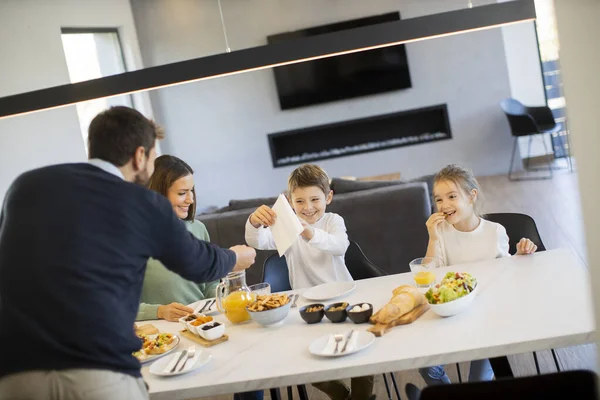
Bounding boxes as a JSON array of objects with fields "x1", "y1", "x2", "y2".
[{"x1": 0, "y1": 0, "x2": 150, "y2": 198}]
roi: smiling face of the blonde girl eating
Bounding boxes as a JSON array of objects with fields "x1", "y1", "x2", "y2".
[{"x1": 433, "y1": 181, "x2": 477, "y2": 225}]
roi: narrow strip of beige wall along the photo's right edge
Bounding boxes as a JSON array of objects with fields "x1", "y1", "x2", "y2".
[{"x1": 555, "y1": 0, "x2": 600, "y2": 368}]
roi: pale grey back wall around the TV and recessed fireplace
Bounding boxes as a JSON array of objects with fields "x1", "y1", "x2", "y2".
[{"x1": 132, "y1": 0, "x2": 524, "y2": 206}]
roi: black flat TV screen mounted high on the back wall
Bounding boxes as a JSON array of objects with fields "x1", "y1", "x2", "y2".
[{"x1": 267, "y1": 12, "x2": 411, "y2": 110}]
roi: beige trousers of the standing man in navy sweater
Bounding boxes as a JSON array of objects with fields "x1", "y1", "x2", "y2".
[{"x1": 0, "y1": 369, "x2": 148, "y2": 400}]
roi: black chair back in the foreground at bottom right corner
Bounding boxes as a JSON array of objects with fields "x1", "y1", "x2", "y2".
[{"x1": 420, "y1": 371, "x2": 598, "y2": 400}]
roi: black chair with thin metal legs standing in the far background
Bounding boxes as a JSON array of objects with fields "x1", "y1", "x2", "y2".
[{"x1": 500, "y1": 98, "x2": 571, "y2": 181}]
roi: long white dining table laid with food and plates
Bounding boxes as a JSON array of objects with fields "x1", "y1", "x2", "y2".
[{"x1": 142, "y1": 249, "x2": 595, "y2": 400}]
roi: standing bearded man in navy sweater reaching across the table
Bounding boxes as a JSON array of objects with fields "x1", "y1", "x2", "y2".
[{"x1": 0, "y1": 107, "x2": 256, "y2": 400}]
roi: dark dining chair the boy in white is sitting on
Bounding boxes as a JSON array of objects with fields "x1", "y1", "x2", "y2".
[{"x1": 263, "y1": 240, "x2": 400, "y2": 400}]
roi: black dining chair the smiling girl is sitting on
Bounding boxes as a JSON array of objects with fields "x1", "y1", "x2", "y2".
[{"x1": 483, "y1": 213, "x2": 560, "y2": 377}]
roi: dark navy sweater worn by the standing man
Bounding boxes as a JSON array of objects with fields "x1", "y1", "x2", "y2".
[{"x1": 0, "y1": 164, "x2": 236, "y2": 378}]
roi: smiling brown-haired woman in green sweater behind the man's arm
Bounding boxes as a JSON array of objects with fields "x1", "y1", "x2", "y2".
[{"x1": 136, "y1": 155, "x2": 219, "y2": 321}]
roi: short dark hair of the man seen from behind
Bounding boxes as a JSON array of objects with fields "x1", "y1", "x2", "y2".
[{"x1": 88, "y1": 106, "x2": 164, "y2": 167}]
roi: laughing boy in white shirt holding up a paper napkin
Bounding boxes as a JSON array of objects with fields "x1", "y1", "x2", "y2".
[{"x1": 246, "y1": 164, "x2": 373, "y2": 400}]
